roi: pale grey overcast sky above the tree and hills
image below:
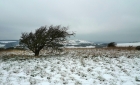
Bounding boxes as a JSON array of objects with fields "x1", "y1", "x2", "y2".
[{"x1": 0, "y1": 0, "x2": 140, "y2": 42}]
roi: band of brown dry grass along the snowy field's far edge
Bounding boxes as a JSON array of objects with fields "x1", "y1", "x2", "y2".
[{"x1": 0, "y1": 47, "x2": 140, "y2": 59}]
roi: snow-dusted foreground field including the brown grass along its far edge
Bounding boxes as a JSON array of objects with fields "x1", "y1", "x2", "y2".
[{"x1": 0, "y1": 49, "x2": 140, "y2": 85}]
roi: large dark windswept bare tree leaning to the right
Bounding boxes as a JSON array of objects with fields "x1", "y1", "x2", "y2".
[{"x1": 20, "y1": 25, "x2": 75, "y2": 56}]
